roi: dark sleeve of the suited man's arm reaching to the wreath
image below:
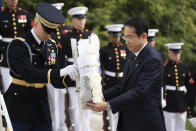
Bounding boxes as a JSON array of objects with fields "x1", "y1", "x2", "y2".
[{"x1": 109, "y1": 59, "x2": 161, "y2": 113}]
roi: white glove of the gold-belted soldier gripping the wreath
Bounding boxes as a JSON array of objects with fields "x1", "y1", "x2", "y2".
[{"x1": 60, "y1": 64, "x2": 79, "y2": 80}]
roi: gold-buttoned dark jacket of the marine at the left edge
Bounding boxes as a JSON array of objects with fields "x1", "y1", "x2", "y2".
[{"x1": 0, "y1": 8, "x2": 31, "y2": 67}]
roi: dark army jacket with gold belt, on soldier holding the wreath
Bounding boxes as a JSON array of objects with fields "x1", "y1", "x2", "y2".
[{"x1": 5, "y1": 32, "x2": 66, "y2": 124}]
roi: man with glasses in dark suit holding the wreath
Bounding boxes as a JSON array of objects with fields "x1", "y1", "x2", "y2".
[{"x1": 87, "y1": 17, "x2": 166, "y2": 131}]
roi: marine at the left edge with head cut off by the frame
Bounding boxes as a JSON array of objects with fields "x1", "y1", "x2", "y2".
[{"x1": 0, "y1": 0, "x2": 31, "y2": 93}]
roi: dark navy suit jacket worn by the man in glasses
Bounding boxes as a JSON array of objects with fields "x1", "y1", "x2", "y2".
[{"x1": 104, "y1": 44, "x2": 166, "y2": 131}]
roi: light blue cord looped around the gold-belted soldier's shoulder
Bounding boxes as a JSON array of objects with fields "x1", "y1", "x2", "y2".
[{"x1": 6, "y1": 37, "x2": 32, "y2": 77}]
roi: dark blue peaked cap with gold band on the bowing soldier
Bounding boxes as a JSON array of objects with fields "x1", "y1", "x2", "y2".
[{"x1": 36, "y1": 2, "x2": 65, "y2": 34}]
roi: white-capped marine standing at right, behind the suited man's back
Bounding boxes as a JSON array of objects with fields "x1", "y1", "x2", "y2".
[{"x1": 163, "y1": 43, "x2": 190, "y2": 131}]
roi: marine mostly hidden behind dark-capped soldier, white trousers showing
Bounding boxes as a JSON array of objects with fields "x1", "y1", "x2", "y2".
[{"x1": 47, "y1": 3, "x2": 70, "y2": 131}]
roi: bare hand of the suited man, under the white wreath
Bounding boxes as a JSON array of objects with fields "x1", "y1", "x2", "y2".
[{"x1": 86, "y1": 102, "x2": 106, "y2": 112}]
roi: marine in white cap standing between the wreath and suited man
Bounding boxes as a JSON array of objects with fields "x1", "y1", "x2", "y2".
[{"x1": 100, "y1": 24, "x2": 129, "y2": 131}]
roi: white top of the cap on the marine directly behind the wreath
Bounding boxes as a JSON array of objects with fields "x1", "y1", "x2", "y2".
[{"x1": 67, "y1": 6, "x2": 88, "y2": 16}]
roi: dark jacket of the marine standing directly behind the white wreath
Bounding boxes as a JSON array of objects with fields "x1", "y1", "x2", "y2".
[{"x1": 61, "y1": 28, "x2": 91, "y2": 87}]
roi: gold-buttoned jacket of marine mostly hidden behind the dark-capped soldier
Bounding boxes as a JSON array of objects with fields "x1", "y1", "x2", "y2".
[{"x1": 52, "y1": 24, "x2": 71, "y2": 68}]
